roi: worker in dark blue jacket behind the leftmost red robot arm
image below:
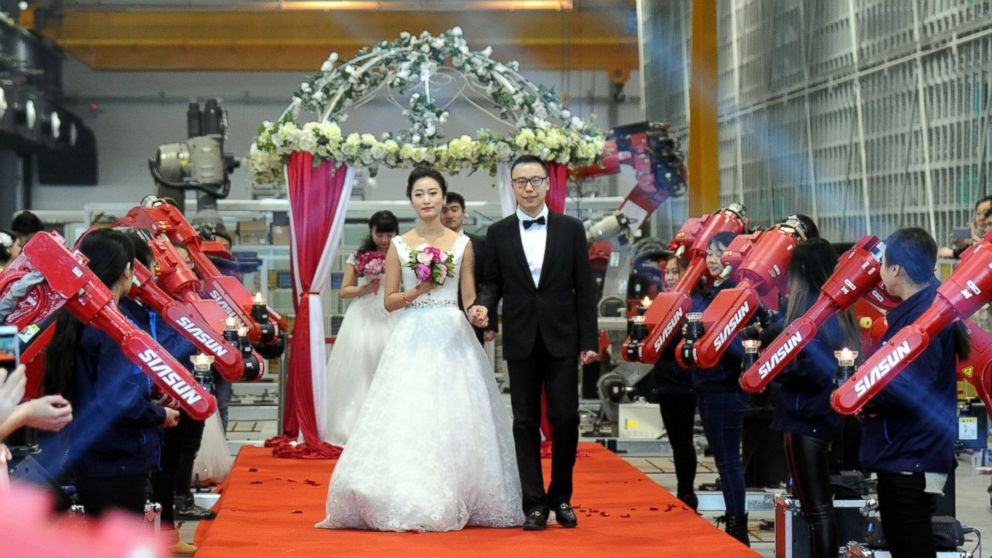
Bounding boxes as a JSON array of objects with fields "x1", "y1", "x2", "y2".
[{"x1": 45, "y1": 229, "x2": 179, "y2": 516}]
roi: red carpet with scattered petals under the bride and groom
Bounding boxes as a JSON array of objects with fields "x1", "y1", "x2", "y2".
[{"x1": 196, "y1": 444, "x2": 757, "y2": 558}]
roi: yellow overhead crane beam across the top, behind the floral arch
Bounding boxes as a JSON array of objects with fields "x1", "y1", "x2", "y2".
[{"x1": 29, "y1": 0, "x2": 638, "y2": 73}]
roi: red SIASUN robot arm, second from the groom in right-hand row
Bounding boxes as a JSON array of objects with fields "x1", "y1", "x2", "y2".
[{"x1": 675, "y1": 218, "x2": 806, "y2": 368}]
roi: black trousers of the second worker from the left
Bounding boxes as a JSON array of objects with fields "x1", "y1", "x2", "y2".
[{"x1": 152, "y1": 410, "x2": 204, "y2": 528}]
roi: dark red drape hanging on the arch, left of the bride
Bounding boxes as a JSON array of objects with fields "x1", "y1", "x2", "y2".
[{"x1": 266, "y1": 152, "x2": 347, "y2": 459}]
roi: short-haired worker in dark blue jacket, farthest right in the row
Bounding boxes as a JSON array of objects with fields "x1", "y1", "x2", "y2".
[{"x1": 861, "y1": 227, "x2": 969, "y2": 558}]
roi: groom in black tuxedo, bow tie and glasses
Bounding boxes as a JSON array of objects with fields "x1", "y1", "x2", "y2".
[{"x1": 469, "y1": 155, "x2": 597, "y2": 531}]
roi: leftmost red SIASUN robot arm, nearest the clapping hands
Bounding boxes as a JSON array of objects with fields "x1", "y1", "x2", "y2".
[{"x1": 0, "y1": 233, "x2": 216, "y2": 420}]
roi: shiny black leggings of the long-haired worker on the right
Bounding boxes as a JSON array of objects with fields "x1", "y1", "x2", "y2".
[{"x1": 784, "y1": 432, "x2": 838, "y2": 558}]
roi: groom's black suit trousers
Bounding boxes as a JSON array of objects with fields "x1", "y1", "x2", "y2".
[{"x1": 506, "y1": 336, "x2": 579, "y2": 513}]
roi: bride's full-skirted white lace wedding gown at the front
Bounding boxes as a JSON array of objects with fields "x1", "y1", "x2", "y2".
[{"x1": 316, "y1": 236, "x2": 524, "y2": 531}]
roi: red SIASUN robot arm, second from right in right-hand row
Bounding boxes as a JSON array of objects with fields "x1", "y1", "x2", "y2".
[{"x1": 741, "y1": 236, "x2": 885, "y2": 393}]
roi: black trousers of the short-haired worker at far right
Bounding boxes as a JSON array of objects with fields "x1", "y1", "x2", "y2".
[{"x1": 877, "y1": 471, "x2": 937, "y2": 558}]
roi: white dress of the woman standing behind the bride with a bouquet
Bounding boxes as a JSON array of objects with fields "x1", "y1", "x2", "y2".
[{"x1": 322, "y1": 256, "x2": 394, "y2": 447}]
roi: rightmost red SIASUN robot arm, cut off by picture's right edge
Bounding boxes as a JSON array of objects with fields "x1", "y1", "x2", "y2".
[{"x1": 830, "y1": 235, "x2": 992, "y2": 415}]
